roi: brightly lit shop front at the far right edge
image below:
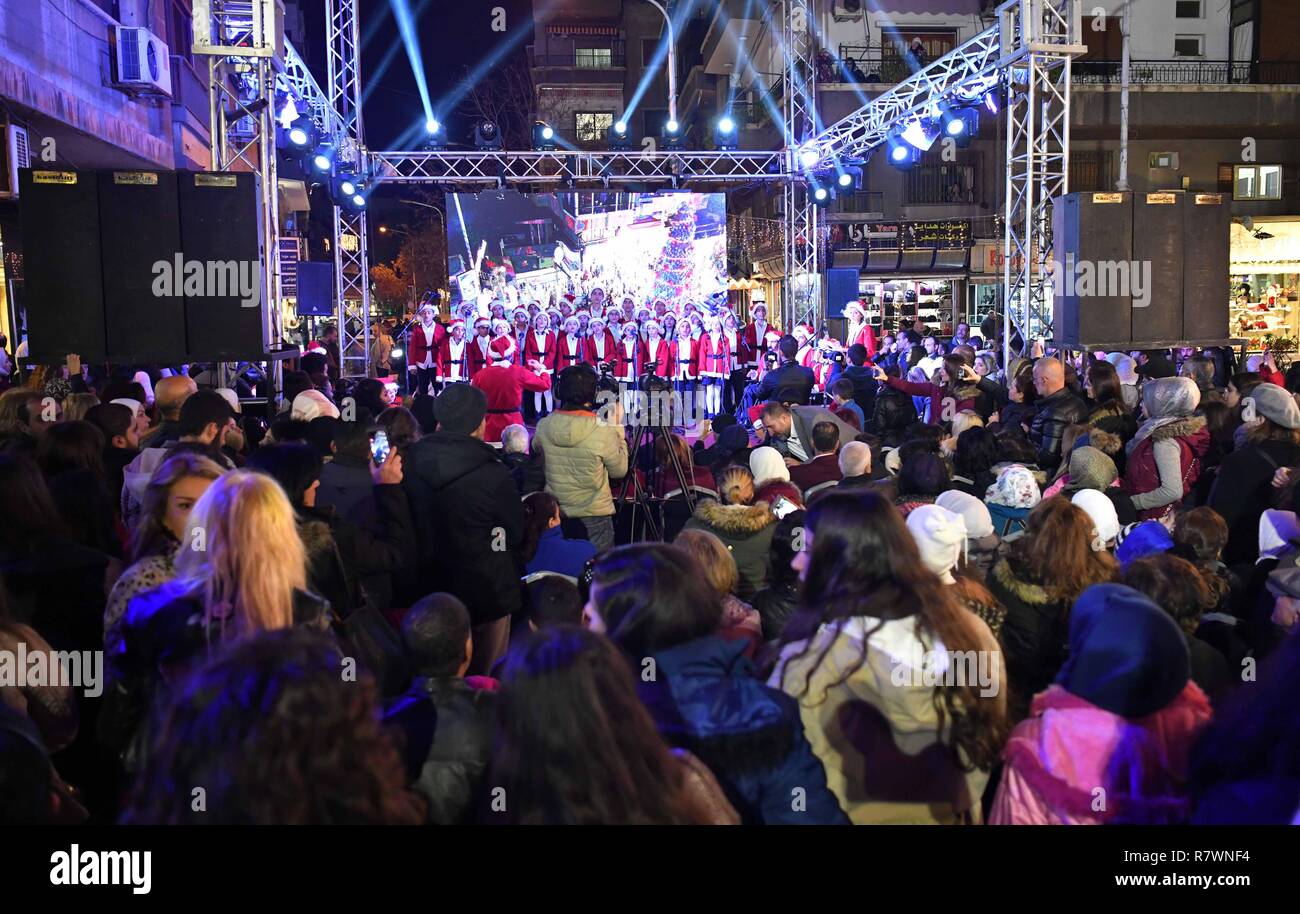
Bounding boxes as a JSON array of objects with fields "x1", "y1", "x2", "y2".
[{"x1": 1229, "y1": 218, "x2": 1300, "y2": 354}]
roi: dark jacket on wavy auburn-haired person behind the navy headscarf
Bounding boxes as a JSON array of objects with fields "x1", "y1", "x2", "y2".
[{"x1": 987, "y1": 559, "x2": 1070, "y2": 720}]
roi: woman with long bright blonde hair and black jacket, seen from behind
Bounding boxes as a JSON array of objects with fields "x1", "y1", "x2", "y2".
[{"x1": 105, "y1": 469, "x2": 329, "y2": 766}]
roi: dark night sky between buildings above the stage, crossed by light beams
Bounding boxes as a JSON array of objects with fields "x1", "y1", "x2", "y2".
[{"x1": 303, "y1": 0, "x2": 533, "y2": 150}]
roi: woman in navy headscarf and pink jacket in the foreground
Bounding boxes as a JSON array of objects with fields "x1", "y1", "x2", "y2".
[{"x1": 989, "y1": 584, "x2": 1210, "y2": 824}]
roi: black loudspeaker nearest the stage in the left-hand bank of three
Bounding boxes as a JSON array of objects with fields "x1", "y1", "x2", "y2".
[{"x1": 177, "y1": 172, "x2": 267, "y2": 361}]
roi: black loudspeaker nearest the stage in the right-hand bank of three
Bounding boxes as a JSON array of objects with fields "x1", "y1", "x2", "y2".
[{"x1": 1052, "y1": 194, "x2": 1134, "y2": 346}]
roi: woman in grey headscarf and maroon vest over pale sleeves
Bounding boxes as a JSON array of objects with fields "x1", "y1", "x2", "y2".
[{"x1": 1125, "y1": 377, "x2": 1210, "y2": 520}]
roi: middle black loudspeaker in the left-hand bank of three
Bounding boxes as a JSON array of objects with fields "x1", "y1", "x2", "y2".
[{"x1": 99, "y1": 172, "x2": 186, "y2": 364}]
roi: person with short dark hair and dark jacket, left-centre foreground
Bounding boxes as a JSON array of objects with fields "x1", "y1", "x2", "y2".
[{"x1": 384, "y1": 593, "x2": 497, "y2": 826}]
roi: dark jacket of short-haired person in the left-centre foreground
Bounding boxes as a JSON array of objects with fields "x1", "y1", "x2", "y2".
[{"x1": 384, "y1": 676, "x2": 497, "y2": 826}]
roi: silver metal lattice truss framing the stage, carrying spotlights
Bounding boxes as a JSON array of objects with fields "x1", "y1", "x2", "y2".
[{"x1": 195, "y1": 0, "x2": 1086, "y2": 376}]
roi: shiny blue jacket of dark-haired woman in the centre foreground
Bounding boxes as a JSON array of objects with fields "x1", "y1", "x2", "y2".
[{"x1": 638, "y1": 636, "x2": 848, "y2": 826}]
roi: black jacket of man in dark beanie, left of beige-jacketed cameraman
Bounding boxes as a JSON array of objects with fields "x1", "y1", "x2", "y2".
[{"x1": 403, "y1": 432, "x2": 524, "y2": 625}]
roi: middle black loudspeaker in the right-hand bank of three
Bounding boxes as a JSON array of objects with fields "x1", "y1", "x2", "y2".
[{"x1": 1131, "y1": 192, "x2": 1185, "y2": 348}]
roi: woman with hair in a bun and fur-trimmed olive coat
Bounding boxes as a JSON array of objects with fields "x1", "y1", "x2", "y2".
[{"x1": 679, "y1": 467, "x2": 776, "y2": 599}]
